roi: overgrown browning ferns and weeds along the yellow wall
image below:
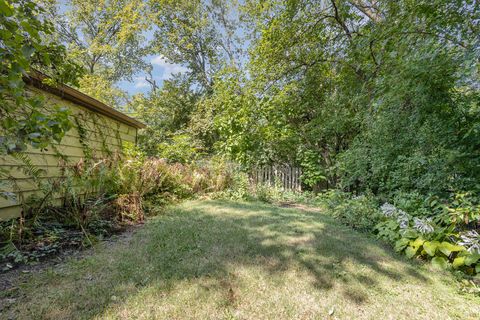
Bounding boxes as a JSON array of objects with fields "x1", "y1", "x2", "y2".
[{"x1": 0, "y1": 145, "x2": 238, "y2": 271}]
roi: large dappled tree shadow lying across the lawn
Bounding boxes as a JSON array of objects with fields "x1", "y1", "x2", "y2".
[{"x1": 15, "y1": 200, "x2": 428, "y2": 318}]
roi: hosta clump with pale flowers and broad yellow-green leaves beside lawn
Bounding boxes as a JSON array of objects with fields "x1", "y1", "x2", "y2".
[{"x1": 376, "y1": 199, "x2": 480, "y2": 274}]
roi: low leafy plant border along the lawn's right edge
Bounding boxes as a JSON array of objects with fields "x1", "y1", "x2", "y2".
[{"x1": 296, "y1": 191, "x2": 480, "y2": 294}]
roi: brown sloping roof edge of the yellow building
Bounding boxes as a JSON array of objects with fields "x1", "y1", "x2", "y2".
[{"x1": 24, "y1": 70, "x2": 146, "y2": 129}]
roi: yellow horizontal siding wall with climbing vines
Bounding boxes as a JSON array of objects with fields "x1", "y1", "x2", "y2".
[{"x1": 0, "y1": 87, "x2": 137, "y2": 220}]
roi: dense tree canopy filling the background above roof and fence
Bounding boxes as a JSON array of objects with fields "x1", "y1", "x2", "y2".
[{"x1": 1, "y1": 0, "x2": 480, "y2": 199}]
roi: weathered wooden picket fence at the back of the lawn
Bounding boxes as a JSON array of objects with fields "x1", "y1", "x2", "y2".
[{"x1": 250, "y1": 165, "x2": 302, "y2": 191}]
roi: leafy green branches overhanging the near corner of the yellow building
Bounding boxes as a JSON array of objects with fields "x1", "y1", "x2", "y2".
[{"x1": 0, "y1": 0, "x2": 82, "y2": 154}]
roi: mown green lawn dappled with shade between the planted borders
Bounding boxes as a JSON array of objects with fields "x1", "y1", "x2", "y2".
[{"x1": 0, "y1": 200, "x2": 480, "y2": 320}]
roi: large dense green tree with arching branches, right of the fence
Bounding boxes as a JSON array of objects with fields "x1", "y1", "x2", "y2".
[{"x1": 236, "y1": 0, "x2": 480, "y2": 193}]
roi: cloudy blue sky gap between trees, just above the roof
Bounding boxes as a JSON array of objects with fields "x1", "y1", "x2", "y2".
[{"x1": 118, "y1": 55, "x2": 188, "y2": 95}]
